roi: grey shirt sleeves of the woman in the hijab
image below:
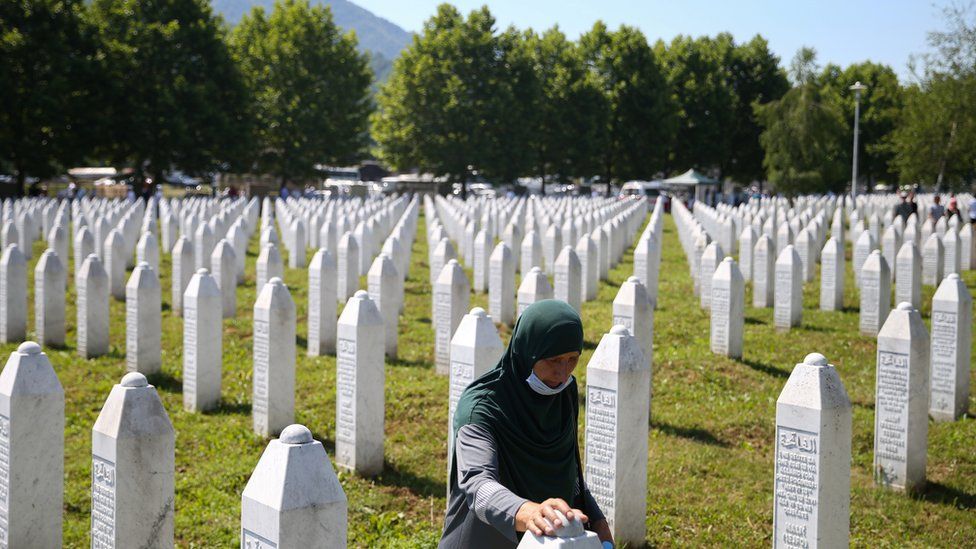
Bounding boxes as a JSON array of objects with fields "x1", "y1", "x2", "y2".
[{"x1": 438, "y1": 425, "x2": 604, "y2": 549}]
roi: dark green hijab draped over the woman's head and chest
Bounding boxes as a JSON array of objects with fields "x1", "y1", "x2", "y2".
[{"x1": 451, "y1": 299, "x2": 583, "y2": 505}]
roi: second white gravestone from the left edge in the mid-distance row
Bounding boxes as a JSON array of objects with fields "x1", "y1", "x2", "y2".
[{"x1": 34, "y1": 248, "x2": 68, "y2": 347}]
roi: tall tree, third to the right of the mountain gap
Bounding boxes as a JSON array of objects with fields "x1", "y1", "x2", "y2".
[{"x1": 580, "y1": 21, "x2": 677, "y2": 189}]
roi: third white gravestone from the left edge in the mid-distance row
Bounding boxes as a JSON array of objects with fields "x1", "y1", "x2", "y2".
[{"x1": 75, "y1": 254, "x2": 108, "y2": 358}]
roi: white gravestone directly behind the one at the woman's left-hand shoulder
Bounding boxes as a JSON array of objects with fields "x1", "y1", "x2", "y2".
[{"x1": 431, "y1": 259, "x2": 471, "y2": 375}]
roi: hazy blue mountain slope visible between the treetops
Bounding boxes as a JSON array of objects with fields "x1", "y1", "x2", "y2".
[{"x1": 212, "y1": 0, "x2": 413, "y2": 82}]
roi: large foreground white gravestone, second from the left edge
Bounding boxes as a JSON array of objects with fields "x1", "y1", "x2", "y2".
[{"x1": 91, "y1": 372, "x2": 176, "y2": 549}]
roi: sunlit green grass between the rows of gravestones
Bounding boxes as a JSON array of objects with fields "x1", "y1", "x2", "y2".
[{"x1": 0, "y1": 216, "x2": 976, "y2": 547}]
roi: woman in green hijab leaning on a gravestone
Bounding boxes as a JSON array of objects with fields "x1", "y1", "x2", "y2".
[{"x1": 440, "y1": 299, "x2": 613, "y2": 549}]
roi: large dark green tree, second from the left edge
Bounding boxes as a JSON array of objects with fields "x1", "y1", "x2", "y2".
[{"x1": 90, "y1": 0, "x2": 247, "y2": 189}]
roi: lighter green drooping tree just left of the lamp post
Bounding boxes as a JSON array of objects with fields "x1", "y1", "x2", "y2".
[{"x1": 756, "y1": 48, "x2": 847, "y2": 195}]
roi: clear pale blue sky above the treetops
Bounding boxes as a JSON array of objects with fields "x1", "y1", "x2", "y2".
[{"x1": 352, "y1": 0, "x2": 946, "y2": 81}]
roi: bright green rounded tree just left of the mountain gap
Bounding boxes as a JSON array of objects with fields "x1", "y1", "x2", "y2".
[{"x1": 230, "y1": 0, "x2": 372, "y2": 184}]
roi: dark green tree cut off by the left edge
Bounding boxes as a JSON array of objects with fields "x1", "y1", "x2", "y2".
[{"x1": 0, "y1": 0, "x2": 98, "y2": 194}]
